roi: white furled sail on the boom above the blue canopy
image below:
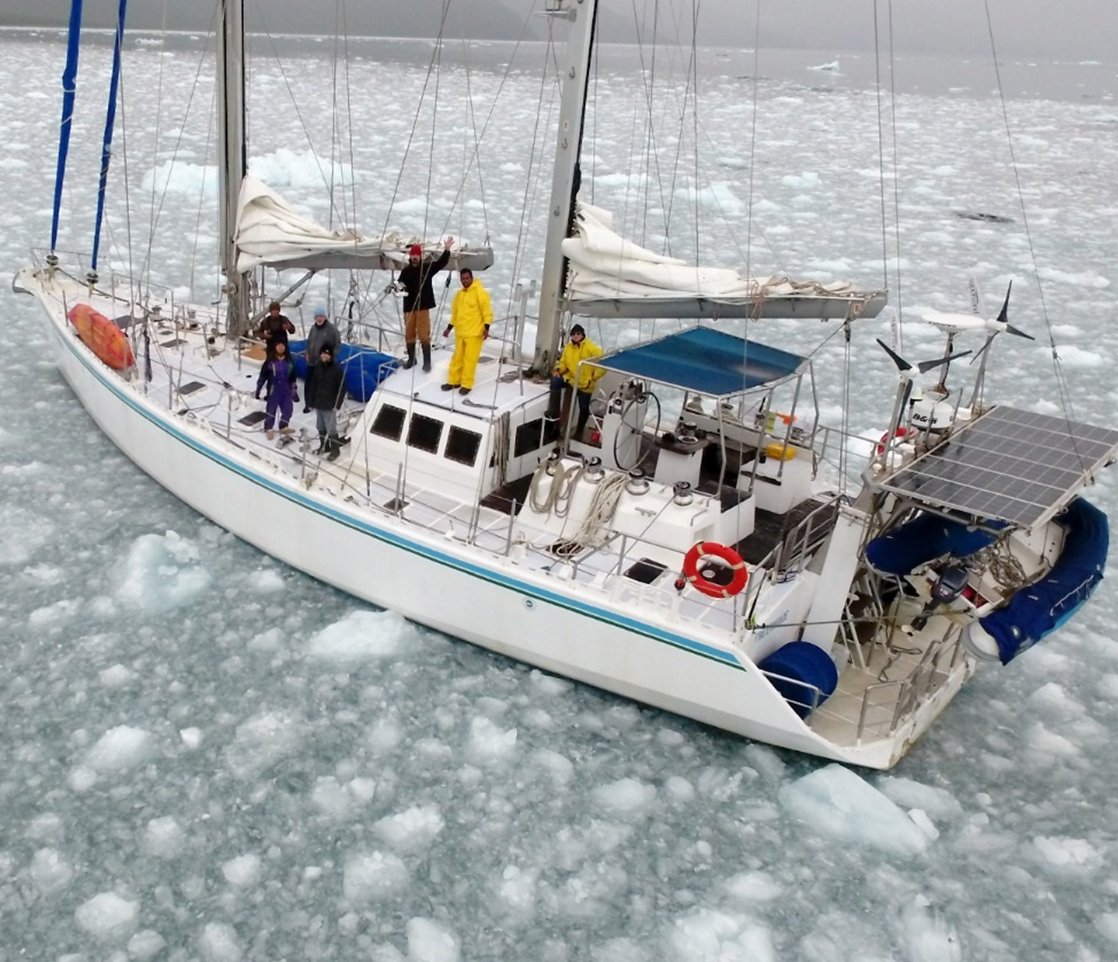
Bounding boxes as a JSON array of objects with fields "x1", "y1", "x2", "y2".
[{"x1": 562, "y1": 204, "x2": 885, "y2": 318}]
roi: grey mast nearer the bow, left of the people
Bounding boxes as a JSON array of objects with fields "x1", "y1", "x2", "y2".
[{"x1": 217, "y1": 0, "x2": 248, "y2": 334}]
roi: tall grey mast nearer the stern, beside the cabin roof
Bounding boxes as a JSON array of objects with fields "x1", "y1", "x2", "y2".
[{"x1": 532, "y1": 0, "x2": 598, "y2": 374}]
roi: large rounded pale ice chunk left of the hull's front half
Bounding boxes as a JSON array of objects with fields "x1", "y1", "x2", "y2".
[{"x1": 116, "y1": 531, "x2": 210, "y2": 611}]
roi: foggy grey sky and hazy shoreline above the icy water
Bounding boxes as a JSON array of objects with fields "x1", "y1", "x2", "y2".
[{"x1": 0, "y1": 0, "x2": 1118, "y2": 63}]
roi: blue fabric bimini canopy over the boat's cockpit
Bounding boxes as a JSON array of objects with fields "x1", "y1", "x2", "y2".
[{"x1": 591, "y1": 328, "x2": 807, "y2": 397}]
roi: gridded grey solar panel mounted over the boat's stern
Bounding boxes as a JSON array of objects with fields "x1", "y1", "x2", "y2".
[{"x1": 879, "y1": 406, "x2": 1118, "y2": 527}]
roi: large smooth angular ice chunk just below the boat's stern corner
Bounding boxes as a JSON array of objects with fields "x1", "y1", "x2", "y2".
[{"x1": 778, "y1": 765, "x2": 928, "y2": 855}]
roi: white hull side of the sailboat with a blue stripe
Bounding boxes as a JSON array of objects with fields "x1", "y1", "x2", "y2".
[{"x1": 16, "y1": 265, "x2": 968, "y2": 767}]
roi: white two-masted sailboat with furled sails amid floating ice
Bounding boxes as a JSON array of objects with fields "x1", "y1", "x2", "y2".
[{"x1": 13, "y1": 0, "x2": 1118, "y2": 768}]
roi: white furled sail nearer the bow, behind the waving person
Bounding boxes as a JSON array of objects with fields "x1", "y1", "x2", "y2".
[{"x1": 236, "y1": 175, "x2": 493, "y2": 272}]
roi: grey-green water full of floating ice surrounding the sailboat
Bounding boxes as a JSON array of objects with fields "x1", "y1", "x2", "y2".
[{"x1": 0, "y1": 20, "x2": 1118, "y2": 962}]
